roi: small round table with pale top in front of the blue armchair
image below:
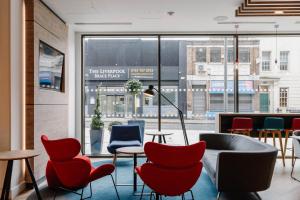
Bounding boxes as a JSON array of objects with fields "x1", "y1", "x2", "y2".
[{"x1": 116, "y1": 147, "x2": 144, "y2": 193}]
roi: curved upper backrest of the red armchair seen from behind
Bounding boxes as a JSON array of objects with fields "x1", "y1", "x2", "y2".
[{"x1": 144, "y1": 141, "x2": 206, "y2": 169}]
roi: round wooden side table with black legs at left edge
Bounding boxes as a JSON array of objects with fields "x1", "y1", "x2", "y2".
[{"x1": 0, "y1": 150, "x2": 42, "y2": 200}]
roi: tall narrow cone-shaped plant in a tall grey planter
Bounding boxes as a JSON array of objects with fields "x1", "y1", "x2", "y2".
[{"x1": 90, "y1": 87, "x2": 104, "y2": 154}]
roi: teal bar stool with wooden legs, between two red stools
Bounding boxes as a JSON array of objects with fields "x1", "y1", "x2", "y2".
[{"x1": 259, "y1": 117, "x2": 285, "y2": 166}]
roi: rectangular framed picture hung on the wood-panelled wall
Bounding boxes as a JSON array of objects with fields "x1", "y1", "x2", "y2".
[{"x1": 39, "y1": 41, "x2": 65, "y2": 92}]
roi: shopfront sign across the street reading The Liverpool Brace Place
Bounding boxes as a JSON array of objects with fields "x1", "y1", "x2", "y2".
[{"x1": 85, "y1": 66, "x2": 178, "y2": 81}]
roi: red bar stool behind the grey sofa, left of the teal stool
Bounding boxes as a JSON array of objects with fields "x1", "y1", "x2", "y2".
[{"x1": 229, "y1": 117, "x2": 253, "y2": 136}]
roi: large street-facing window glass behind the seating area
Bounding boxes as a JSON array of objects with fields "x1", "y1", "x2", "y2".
[{"x1": 83, "y1": 36, "x2": 300, "y2": 154}]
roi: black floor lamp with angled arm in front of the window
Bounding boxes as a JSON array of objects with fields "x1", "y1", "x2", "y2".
[{"x1": 144, "y1": 85, "x2": 189, "y2": 146}]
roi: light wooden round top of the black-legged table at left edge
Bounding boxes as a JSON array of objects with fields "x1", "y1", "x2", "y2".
[{"x1": 0, "y1": 150, "x2": 40, "y2": 160}]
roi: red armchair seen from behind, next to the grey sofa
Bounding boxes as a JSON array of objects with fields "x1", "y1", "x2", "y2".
[{"x1": 136, "y1": 141, "x2": 206, "y2": 199}]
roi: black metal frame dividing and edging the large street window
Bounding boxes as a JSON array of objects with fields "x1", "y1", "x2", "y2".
[{"x1": 81, "y1": 32, "x2": 300, "y2": 157}]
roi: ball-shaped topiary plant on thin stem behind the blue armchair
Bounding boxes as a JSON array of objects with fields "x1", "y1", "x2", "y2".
[{"x1": 125, "y1": 79, "x2": 145, "y2": 143}]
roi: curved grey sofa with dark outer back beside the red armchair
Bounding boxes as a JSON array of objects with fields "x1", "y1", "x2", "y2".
[{"x1": 200, "y1": 133, "x2": 278, "y2": 198}]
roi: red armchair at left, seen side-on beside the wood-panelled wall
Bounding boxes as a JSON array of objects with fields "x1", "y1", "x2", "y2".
[{"x1": 41, "y1": 135, "x2": 120, "y2": 199}]
